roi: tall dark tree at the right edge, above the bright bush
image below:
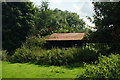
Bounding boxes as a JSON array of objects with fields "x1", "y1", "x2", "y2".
[{"x1": 89, "y1": 2, "x2": 120, "y2": 55}]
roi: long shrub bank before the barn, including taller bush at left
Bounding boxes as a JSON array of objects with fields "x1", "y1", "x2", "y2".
[{"x1": 11, "y1": 35, "x2": 99, "y2": 65}]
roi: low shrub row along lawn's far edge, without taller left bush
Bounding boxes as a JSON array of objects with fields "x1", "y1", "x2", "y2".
[{"x1": 12, "y1": 45, "x2": 98, "y2": 65}]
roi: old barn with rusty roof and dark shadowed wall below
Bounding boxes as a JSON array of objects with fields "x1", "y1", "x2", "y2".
[{"x1": 46, "y1": 33, "x2": 87, "y2": 47}]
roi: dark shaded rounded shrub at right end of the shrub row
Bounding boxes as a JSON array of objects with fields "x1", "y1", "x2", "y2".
[{"x1": 74, "y1": 47, "x2": 99, "y2": 63}]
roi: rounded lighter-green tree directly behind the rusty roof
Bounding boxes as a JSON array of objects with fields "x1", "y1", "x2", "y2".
[{"x1": 50, "y1": 8, "x2": 86, "y2": 33}]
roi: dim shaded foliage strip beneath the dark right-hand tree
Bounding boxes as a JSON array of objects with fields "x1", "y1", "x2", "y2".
[{"x1": 86, "y1": 43, "x2": 120, "y2": 56}]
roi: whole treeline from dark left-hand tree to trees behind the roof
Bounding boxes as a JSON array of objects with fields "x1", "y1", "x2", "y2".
[{"x1": 2, "y1": 1, "x2": 90, "y2": 53}]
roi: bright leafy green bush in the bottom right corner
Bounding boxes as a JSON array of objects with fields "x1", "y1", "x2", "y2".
[{"x1": 80, "y1": 54, "x2": 120, "y2": 78}]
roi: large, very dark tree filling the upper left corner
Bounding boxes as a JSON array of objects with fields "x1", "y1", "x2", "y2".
[{"x1": 2, "y1": 2, "x2": 35, "y2": 52}]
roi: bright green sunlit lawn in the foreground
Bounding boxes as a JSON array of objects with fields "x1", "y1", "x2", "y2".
[{"x1": 2, "y1": 62, "x2": 84, "y2": 78}]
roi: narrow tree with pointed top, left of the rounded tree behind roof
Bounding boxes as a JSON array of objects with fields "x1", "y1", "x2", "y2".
[{"x1": 35, "y1": 0, "x2": 52, "y2": 36}]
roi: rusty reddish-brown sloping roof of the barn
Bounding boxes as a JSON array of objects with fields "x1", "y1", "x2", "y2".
[{"x1": 46, "y1": 33, "x2": 86, "y2": 41}]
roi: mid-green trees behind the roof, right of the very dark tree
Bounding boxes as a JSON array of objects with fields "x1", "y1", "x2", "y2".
[{"x1": 35, "y1": 2, "x2": 86, "y2": 36}]
